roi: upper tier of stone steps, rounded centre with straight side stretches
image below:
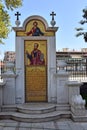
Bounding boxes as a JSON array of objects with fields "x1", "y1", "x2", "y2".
[{"x1": 1, "y1": 103, "x2": 70, "y2": 114}]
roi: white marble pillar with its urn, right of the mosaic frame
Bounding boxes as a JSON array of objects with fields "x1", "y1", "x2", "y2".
[{"x1": 55, "y1": 60, "x2": 69, "y2": 104}]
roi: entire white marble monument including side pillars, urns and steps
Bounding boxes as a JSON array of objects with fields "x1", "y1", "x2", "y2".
[{"x1": 0, "y1": 12, "x2": 87, "y2": 122}]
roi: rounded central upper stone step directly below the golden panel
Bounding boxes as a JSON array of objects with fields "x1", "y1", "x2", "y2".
[{"x1": 17, "y1": 103, "x2": 56, "y2": 114}]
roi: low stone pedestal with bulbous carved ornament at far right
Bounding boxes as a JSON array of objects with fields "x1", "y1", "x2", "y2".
[{"x1": 68, "y1": 81, "x2": 86, "y2": 116}]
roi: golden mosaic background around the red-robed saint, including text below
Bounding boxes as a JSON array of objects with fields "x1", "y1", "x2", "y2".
[{"x1": 24, "y1": 40, "x2": 47, "y2": 102}]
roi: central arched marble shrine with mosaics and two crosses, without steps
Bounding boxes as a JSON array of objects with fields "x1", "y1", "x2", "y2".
[{"x1": 13, "y1": 12, "x2": 58, "y2": 103}]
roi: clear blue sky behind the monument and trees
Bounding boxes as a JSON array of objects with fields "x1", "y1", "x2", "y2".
[{"x1": 0, "y1": 0, "x2": 87, "y2": 58}]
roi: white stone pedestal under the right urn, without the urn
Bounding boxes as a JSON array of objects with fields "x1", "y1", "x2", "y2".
[{"x1": 55, "y1": 72, "x2": 69, "y2": 104}]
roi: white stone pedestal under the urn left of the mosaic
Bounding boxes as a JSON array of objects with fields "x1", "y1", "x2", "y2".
[{"x1": 2, "y1": 74, "x2": 16, "y2": 105}]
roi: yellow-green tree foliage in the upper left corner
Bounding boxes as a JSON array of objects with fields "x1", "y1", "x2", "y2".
[{"x1": 0, "y1": 0, "x2": 22, "y2": 43}]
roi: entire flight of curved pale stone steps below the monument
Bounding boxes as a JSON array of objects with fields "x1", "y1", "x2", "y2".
[{"x1": 0, "y1": 103, "x2": 71, "y2": 123}]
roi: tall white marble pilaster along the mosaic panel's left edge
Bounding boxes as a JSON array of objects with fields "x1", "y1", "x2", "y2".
[{"x1": 16, "y1": 37, "x2": 25, "y2": 104}]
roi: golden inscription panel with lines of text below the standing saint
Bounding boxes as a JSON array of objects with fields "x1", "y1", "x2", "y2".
[{"x1": 26, "y1": 66, "x2": 47, "y2": 101}]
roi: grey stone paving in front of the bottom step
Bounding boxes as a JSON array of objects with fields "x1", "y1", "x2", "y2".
[{"x1": 0, "y1": 119, "x2": 87, "y2": 130}]
